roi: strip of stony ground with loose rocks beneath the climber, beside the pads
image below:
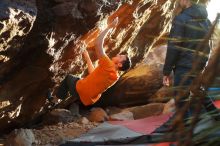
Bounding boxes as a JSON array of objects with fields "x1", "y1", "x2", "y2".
[{"x1": 0, "y1": 102, "x2": 172, "y2": 146}]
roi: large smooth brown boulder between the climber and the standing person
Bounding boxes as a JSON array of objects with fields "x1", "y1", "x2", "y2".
[{"x1": 97, "y1": 45, "x2": 170, "y2": 106}]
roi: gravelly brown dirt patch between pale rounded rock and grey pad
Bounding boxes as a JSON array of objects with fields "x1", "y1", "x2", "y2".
[{"x1": 33, "y1": 118, "x2": 98, "y2": 145}]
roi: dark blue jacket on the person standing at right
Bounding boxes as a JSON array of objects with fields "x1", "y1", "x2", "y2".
[{"x1": 163, "y1": 5, "x2": 211, "y2": 75}]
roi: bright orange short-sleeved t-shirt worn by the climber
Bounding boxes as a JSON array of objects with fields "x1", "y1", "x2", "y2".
[{"x1": 76, "y1": 55, "x2": 119, "y2": 105}]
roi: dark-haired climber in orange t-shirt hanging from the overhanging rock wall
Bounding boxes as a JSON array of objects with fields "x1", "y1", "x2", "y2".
[{"x1": 48, "y1": 18, "x2": 131, "y2": 106}]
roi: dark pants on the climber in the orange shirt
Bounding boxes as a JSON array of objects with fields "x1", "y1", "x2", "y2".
[{"x1": 56, "y1": 74, "x2": 80, "y2": 100}]
